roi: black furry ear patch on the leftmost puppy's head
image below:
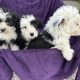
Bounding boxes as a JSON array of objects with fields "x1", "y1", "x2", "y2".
[{"x1": 5, "y1": 13, "x2": 21, "y2": 35}]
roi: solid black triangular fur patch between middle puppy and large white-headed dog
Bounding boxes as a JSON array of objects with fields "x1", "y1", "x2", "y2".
[{"x1": 28, "y1": 34, "x2": 54, "y2": 49}]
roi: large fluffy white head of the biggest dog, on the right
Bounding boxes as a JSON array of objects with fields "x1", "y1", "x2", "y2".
[{"x1": 45, "y1": 6, "x2": 80, "y2": 36}]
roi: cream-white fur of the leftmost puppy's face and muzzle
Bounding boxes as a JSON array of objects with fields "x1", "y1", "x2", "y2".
[{"x1": 0, "y1": 22, "x2": 17, "y2": 42}]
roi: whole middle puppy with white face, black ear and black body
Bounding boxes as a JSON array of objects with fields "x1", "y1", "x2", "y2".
[{"x1": 17, "y1": 15, "x2": 41, "y2": 49}]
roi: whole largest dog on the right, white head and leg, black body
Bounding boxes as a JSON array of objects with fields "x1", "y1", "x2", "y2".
[{"x1": 28, "y1": 5, "x2": 80, "y2": 61}]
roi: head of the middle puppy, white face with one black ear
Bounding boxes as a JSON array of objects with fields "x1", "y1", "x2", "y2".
[{"x1": 20, "y1": 15, "x2": 40, "y2": 41}]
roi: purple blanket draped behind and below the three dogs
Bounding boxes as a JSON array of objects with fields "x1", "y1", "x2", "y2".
[{"x1": 0, "y1": 0, "x2": 80, "y2": 80}]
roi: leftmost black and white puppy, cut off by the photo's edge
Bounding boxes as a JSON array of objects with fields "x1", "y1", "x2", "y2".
[{"x1": 0, "y1": 8, "x2": 19, "y2": 50}]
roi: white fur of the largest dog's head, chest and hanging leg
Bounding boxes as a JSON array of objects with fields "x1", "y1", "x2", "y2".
[{"x1": 44, "y1": 5, "x2": 80, "y2": 61}]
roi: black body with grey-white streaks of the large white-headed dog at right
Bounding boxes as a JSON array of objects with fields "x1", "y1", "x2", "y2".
[{"x1": 28, "y1": 31, "x2": 54, "y2": 49}]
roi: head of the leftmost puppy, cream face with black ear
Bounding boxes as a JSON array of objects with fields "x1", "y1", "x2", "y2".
[{"x1": 0, "y1": 8, "x2": 17, "y2": 42}]
